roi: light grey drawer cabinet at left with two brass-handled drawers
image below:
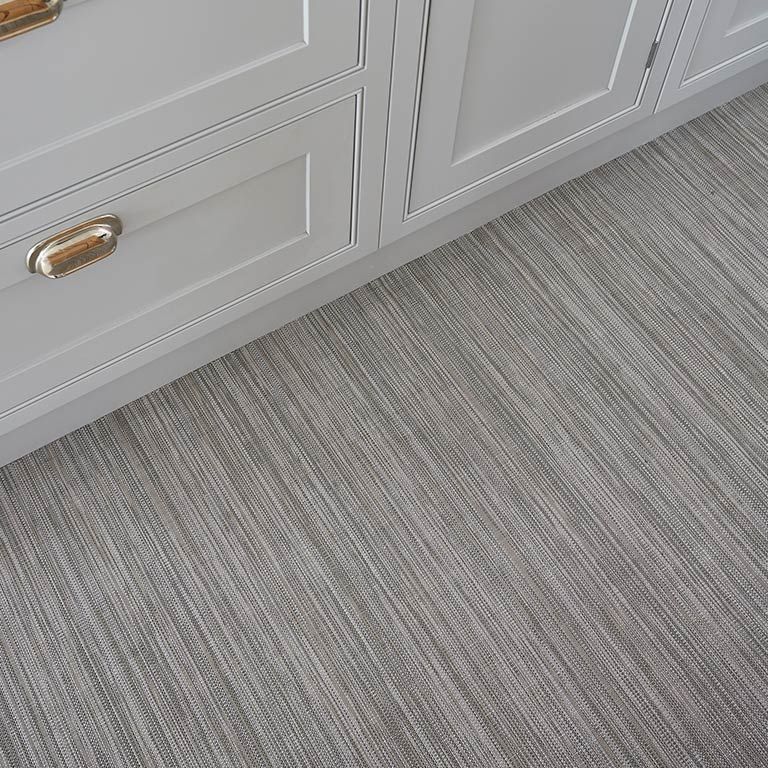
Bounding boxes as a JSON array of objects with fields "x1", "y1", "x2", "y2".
[{"x1": 0, "y1": 0, "x2": 395, "y2": 465}]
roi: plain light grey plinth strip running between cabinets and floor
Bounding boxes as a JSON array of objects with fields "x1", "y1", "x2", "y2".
[{"x1": 0, "y1": 62, "x2": 768, "y2": 466}]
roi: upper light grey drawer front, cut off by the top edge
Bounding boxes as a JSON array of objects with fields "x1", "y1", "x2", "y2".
[{"x1": 0, "y1": 0, "x2": 364, "y2": 222}]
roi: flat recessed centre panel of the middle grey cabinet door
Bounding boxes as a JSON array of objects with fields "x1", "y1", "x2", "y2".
[{"x1": 452, "y1": 0, "x2": 631, "y2": 163}]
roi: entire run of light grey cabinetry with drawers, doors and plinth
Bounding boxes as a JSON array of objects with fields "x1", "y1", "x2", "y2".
[{"x1": 0, "y1": 0, "x2": 768, "y2": 464}]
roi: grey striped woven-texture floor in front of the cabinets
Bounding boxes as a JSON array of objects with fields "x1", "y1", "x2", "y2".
[{"x1": 0, "y1": 88, "x2": 768, "y2": 768}]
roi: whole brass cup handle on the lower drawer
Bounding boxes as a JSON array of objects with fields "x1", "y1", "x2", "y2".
[{"x1": 27, "y1": 215, "x2": 123, "y2": 278}]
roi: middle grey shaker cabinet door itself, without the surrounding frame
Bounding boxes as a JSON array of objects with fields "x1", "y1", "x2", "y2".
[{"x1": 409, "y1": 0, "x2": 667, "y2": 211}]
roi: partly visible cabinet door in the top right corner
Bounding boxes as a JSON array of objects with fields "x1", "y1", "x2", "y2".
[{"x1": 659, "y1": 0, "x2": 768, "y2": 109}]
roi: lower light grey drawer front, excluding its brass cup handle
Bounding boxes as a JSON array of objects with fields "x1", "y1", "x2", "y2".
[{"x1": 0, "y1": 96, "x2": 358, "y2": 420}]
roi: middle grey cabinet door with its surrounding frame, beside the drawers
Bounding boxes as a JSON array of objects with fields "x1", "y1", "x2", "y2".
[{"x1": 385, "y1": 0, "x2": 670, "y2": 240}]
